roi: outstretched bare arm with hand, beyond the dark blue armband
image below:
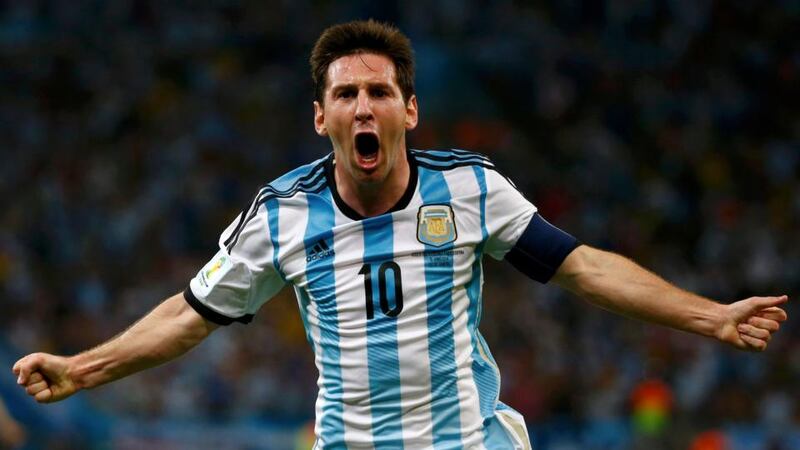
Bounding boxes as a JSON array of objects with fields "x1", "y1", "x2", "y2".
[{"x1": 553, "y1": 245, "x2": 788, "y2": 351}]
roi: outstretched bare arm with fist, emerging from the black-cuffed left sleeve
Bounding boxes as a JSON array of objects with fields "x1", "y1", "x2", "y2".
[{"x1": 13, "y1": 294, "x2": 217, "y2": 403}]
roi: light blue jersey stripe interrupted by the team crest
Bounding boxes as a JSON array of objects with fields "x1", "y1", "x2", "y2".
[{"x1": 419, "y1": 167, "x2": 463, "y2": 449}]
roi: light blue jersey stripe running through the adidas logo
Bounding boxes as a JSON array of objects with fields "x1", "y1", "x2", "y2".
[{"x1": 304, "y1": 190, "x2": 345, "y2": 449}]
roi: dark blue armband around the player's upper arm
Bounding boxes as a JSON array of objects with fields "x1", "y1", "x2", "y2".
[{"x1": 505, "y1": 213, "x2": 580, "y2": 283}]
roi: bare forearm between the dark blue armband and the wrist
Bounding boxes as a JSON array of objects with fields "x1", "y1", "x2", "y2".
[{"x1": 555, "y1": 246, "x2": 723, "y2": 336}]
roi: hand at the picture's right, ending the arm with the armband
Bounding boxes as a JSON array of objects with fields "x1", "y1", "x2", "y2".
[{"x1": 717, "y1": 295, "x2": 789, "y2": 351}]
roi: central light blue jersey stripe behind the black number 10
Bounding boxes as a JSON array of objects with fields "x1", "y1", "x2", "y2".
[{"x1": 362, "y1": 214, "x2": 403, "y2": 449}]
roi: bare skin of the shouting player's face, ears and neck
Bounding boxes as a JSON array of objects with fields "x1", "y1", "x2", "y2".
[{"x1": 314, "y1": 53, "x2": 419, "y2": 217}]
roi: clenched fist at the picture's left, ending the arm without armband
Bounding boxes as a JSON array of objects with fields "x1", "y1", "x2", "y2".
[{"x1": 12, "y1": 353, "x2": 78, "y2": 403}]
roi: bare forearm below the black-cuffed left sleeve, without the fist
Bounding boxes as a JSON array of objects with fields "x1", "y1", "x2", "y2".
[{"x1": 69, "y1": 294, "x2": 216, "y2": 389}]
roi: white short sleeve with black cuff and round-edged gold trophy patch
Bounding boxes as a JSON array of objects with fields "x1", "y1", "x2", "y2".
[{"x1": 184, "y1": 202, "x2": 285, "y2": 325}]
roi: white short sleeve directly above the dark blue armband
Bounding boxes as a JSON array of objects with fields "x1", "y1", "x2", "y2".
[{"x1": 485, "y1": 169, "x2": 536, "y2": 260}]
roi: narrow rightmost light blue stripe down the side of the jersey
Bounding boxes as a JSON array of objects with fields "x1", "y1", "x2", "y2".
[{"x1": 467, "y1": 166, "x2": 500, "y2": 419}]
